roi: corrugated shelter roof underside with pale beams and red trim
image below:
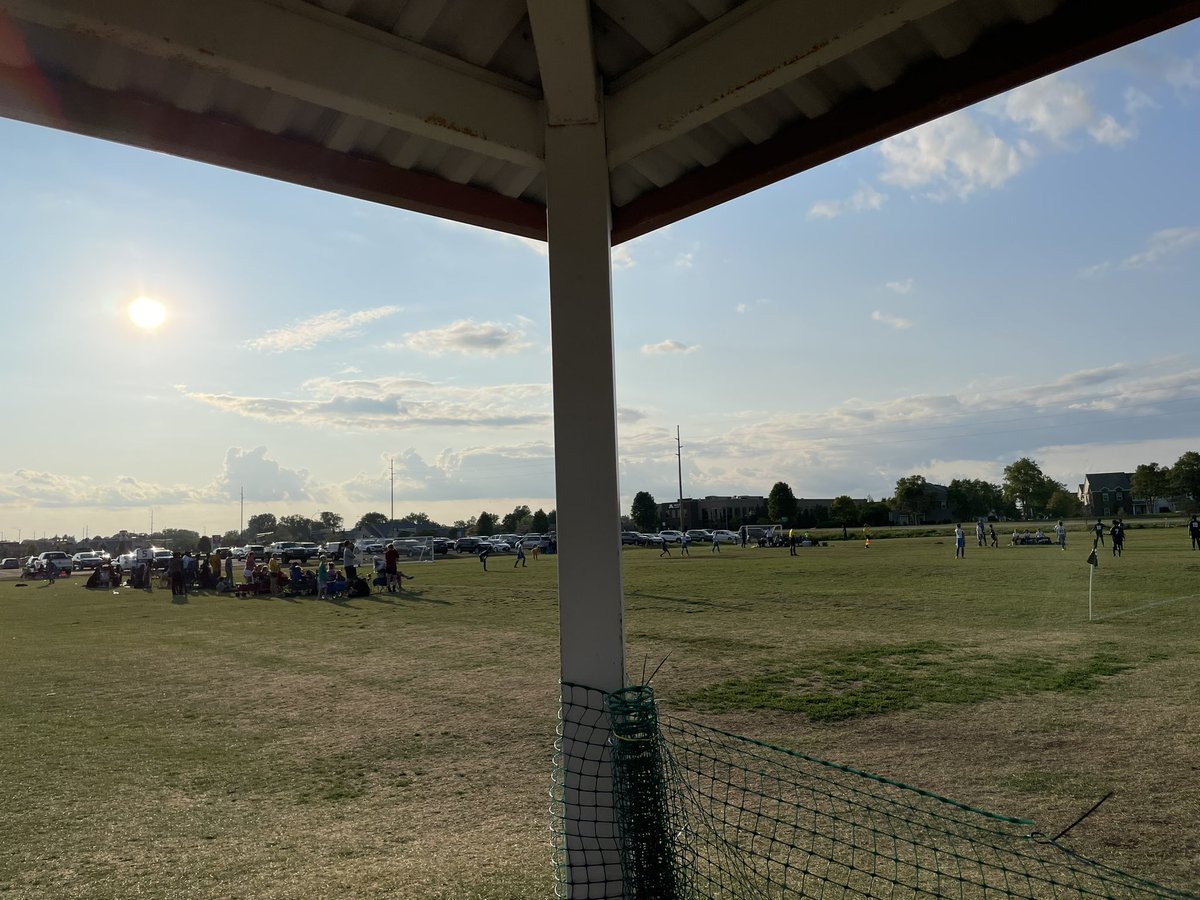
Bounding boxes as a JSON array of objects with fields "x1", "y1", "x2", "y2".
[{"x1": 0, "y1": 0, "x2": 1200, "y2": 242}]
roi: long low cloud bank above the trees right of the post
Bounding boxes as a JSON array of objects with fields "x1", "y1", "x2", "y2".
[{"x1": 620, "y1": 364, "x2": 1200, "y2": 508}]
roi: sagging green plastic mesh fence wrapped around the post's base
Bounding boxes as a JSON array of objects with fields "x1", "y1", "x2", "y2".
[{"x1": 552, "y1": 684, "x2": 1190, "y2": 900}]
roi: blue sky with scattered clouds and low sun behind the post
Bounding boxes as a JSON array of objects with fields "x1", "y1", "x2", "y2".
[{"x1": 0, "y1": 23, "x2": 1200, "y2": 539}]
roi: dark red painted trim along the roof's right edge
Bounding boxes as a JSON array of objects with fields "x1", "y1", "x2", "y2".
[{"x1": 612, "y1": 0, "x2": 1200, "y2": 245}]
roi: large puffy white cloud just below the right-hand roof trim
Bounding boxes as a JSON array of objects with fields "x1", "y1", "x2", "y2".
[{"x1": 880, "y1": 112, "x2": 1033, "y2": 199}]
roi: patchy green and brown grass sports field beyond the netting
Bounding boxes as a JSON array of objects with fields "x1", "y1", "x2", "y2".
[{"x1": 0, "y1": 528, "x2": 1200, "y2": 900}]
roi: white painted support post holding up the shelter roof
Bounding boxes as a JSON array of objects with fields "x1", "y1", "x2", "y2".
[{"x1": 546, "y1": 120, "x2": 625, "y2": 898}]
